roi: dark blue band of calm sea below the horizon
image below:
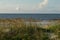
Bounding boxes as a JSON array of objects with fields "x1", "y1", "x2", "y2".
[{"x1": 0, "y1": 14, "x2": 60, "y2": 20}]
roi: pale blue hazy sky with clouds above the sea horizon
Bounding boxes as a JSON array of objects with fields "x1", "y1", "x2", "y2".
[{"x1": 0, "y1": 0, "x2": 60, "y2": 13}]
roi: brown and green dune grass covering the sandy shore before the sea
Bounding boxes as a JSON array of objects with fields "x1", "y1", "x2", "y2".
[{"x1": 0, "y1": 19, "x2": 60, "y2": 40}]
